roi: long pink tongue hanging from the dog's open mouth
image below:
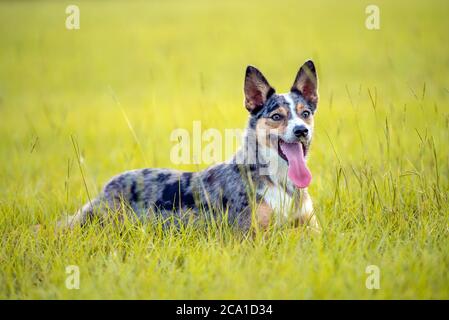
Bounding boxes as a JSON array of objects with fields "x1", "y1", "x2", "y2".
[{"x1": 281, "y1": 143, "x2": 312, "y2": 188}]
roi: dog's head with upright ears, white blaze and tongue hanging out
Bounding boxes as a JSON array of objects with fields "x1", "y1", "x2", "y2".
[{"x1": 244, "y1": 60, "x2": 318, "y2": 188}]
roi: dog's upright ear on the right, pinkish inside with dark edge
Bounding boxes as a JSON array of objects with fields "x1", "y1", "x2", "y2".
[{"x1": 291, "y1": 60, "x2": 318, "y2": 108}]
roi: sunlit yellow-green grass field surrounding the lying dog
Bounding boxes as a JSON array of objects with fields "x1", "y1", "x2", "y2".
[{"x1": 0, "y1": 0, "x2": 449, "y2": 299}]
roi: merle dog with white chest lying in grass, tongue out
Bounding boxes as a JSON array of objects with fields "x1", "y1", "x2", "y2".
[{"x1": 60, "y1": 60, "x2": 320, "y2": 230}]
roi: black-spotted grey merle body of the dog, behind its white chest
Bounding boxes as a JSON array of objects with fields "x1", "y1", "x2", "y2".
[{"x1": 72, "y1": 140, "x2": 269, "y2": 229}]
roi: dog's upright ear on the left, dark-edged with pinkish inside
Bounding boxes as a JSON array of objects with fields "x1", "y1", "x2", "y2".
[{"x1": 244, "y1": 66, "x2": 275, "y2": 113}]
